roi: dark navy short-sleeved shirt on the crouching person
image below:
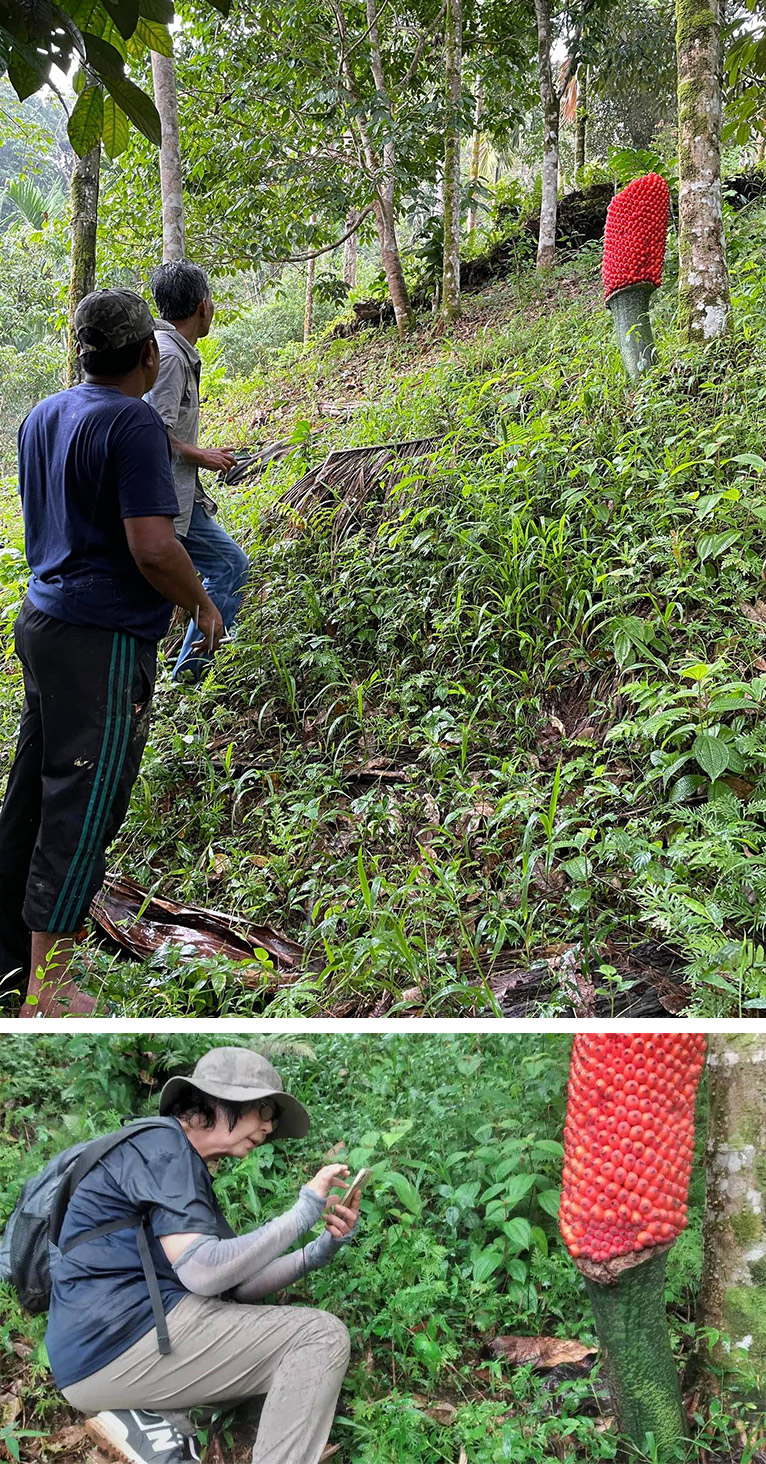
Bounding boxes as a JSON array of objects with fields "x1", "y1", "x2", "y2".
[{"x1": 45, "y1": 1120, "x2": 233, "y2": 1388}]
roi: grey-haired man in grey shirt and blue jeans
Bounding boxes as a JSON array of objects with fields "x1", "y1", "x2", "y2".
[{"x1": 146, "y1": 259, "x2": 249, "y2": 682}]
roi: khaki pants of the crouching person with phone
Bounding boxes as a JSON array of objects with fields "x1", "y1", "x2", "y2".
[{"x1": 63, "y1": 1296, "x2": 349, "y2": 1464}]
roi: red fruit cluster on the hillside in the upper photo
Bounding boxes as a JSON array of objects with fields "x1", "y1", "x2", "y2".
[{"x1": 602, "y1": 173, "x2": 671, "y2": 303}]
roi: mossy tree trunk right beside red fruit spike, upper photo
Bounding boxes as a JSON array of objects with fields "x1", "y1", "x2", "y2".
[{"x1": 675, "y1": 0, "x2": 731, "y2": 341}]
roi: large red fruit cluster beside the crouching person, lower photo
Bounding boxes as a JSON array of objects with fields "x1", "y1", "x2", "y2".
[{"x1": 559, "y1": 1032, "x2": 706, "y2": 1261}]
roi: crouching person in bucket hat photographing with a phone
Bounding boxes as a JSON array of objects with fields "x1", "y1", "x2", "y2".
[{"x1": 52, "y1": 1047, "x2": 359, "y2": 1464}]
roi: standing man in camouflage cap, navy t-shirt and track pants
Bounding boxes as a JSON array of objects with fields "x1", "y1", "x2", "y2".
[{"x1": 0, "y1": 290, "x2": 223, "y2": 1017}]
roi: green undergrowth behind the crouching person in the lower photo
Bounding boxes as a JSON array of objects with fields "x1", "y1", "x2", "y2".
[{"x1": 0, "y1": 1034, "x2": 753, "y2": 1464}]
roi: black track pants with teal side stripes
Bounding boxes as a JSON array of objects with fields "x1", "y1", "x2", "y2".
[{"x1": 0, "y1": 600, "x2": 157, "y2": 976}]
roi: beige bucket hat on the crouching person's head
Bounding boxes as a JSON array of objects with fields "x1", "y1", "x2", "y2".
[{"x1": 160, "y1": 1047, "x2": 311, "y2": 1139}]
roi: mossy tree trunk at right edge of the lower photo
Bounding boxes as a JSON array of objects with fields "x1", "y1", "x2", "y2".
[{"x1": 697, "y1": 1032, "x2": 766, "y2": 1403}]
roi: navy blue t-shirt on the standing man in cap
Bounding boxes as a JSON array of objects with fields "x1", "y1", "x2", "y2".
[{"x1": 19, "y1": 384, "x2": 179, "y2": 640}]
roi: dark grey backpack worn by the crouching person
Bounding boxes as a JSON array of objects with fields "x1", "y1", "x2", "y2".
[{"x1": 0, "y1": 1118, "x2": 176, "y2": 1353}]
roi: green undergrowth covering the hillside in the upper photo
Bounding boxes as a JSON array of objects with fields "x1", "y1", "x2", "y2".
[{"x1": 0, "y1": 208, "x2": 766, "y2": 1016}]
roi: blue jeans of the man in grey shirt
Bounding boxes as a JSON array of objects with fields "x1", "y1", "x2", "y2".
[{"x1": 173, "y1": 504, "x2": 250, "y2": 681}]
